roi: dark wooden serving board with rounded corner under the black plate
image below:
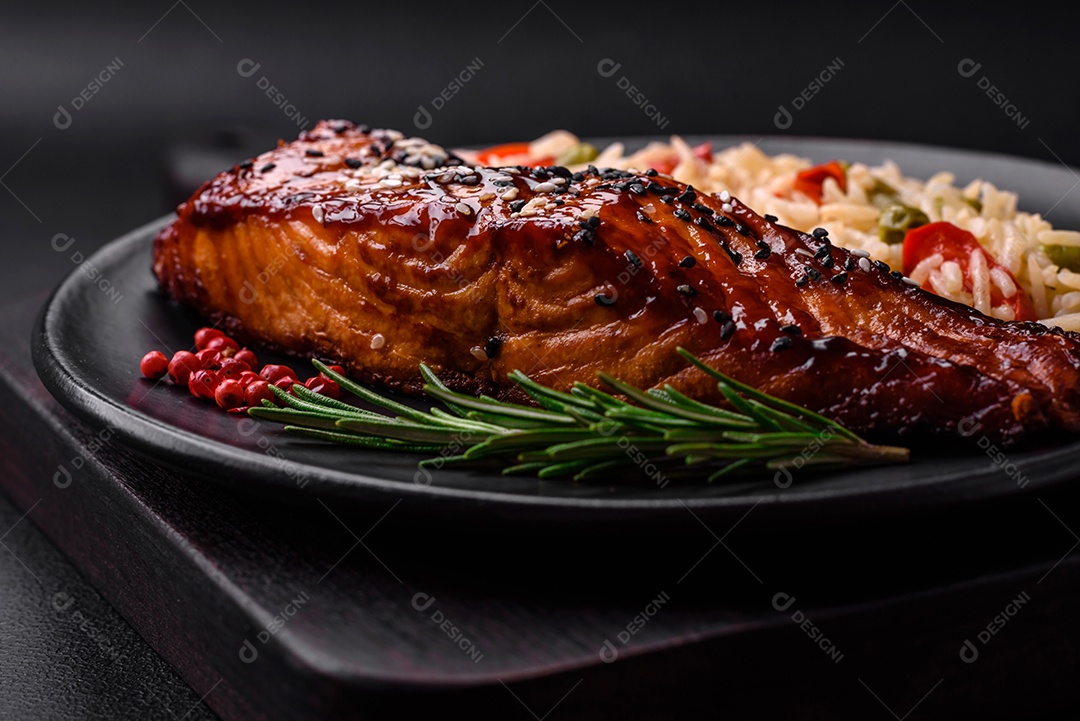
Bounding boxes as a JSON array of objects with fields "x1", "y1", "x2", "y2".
[{"x1": 0, "y1": 295, "x2": 1080, "y2": 720}]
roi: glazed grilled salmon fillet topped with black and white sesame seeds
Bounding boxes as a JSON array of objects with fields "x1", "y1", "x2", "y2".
[{"x1": 153, "y1": 121, "x2": 1080, "y2": 446}]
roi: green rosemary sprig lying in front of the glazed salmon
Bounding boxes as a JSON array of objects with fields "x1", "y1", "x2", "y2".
[{"x1": 247, "y1": 349, "x2": 908, "y2": 486}]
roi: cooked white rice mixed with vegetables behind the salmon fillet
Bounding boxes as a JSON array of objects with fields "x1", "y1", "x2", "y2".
[{"x1": 514, "y1": 131, "x2": 1080, "y2": 330}]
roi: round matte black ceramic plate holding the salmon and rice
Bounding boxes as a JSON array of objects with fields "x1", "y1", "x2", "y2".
[{"x1": 35, "y1": 137, "x2": 1080, "y2": 523}]
